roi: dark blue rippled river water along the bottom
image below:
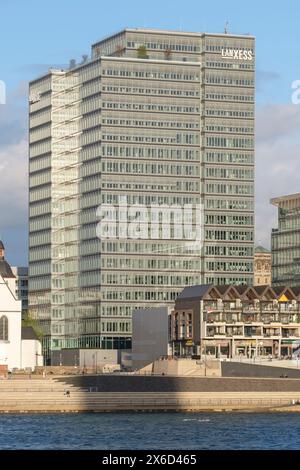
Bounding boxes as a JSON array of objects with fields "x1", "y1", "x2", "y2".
[{"x1": 0, "y1": 413, "x2": 300, "y2": 450}]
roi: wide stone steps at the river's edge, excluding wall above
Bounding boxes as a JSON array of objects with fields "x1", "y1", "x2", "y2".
[{"x1": 0, "y1": 379, "x2": 300, "y2": 413}]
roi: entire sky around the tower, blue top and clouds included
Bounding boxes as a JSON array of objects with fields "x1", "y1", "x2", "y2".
[{"x1": 0, "y1": 0, "x2": 300, "y2": 265}]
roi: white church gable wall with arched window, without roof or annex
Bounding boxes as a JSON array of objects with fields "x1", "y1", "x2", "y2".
[{"x1": 0, "y1": 276, "x2": 22, "y2": 370}]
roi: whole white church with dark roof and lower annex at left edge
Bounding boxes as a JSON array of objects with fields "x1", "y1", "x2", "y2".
[{"x1": 0, "y1": 241, "x2": 43, "y2": 370}]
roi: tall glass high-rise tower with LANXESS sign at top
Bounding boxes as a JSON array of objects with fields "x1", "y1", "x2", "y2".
[{"x1": 29, "y1": 29, "x2": 255, "y2": 355}]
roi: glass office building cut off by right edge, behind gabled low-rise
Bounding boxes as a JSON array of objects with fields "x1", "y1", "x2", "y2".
[{"x1": 271, "y1": 194, "x2": 300, "y2": 286}]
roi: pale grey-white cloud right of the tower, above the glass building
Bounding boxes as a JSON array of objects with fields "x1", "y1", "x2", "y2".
[{"x1": 256, "y1": 104, "x2": 300, "y2": 247}]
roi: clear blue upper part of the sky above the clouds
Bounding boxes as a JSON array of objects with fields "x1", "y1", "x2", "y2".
[{"x1": 0, "y1": 0, "x2": 300, "y2": 102}]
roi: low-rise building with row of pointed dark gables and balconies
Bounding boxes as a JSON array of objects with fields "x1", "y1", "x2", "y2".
[{"x1": 169, "y1": 285, "x2": 300, "y2": 358}]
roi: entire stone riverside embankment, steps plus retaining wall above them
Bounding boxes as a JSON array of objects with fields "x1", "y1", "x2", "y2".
[{"x1": 0, "y1": 376, "x2": 300, "y2": 413}]
